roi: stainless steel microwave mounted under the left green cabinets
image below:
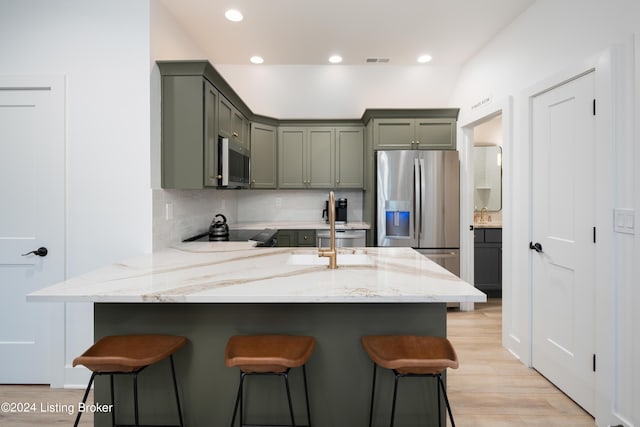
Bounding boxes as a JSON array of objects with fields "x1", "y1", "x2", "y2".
[{"x1": 218, "y1": 138, "x2": 249, "y2": 188}]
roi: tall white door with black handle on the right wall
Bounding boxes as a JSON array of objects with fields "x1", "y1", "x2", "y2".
[{"x1": 531, "y1": 72, "x2": 595, "y2": 413}]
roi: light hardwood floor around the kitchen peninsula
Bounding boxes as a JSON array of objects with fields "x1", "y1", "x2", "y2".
[{"x1": 0, "y1": 300, "x2": 595, "y2": 427}]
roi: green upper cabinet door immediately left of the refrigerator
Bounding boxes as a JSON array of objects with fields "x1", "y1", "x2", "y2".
[{"x1": 335, "y1": 127, "x2": 364, "y2": 188}]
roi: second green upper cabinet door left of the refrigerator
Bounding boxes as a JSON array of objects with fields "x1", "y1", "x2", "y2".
[{"x1": 304, "y1": 128, "x2": 335, "y2": 188}]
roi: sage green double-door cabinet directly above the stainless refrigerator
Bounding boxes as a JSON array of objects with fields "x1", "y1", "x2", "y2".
[{"x1": 373, "y1": 118, "x2": 456, "y2": 150}]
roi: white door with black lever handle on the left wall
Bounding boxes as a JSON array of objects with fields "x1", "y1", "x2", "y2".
[{"x1": 0, "y1": 76, "x2": 65, "y2": 384}]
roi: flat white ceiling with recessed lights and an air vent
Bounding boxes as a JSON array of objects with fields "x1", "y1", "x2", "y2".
[{"x1": 161, "y1": 0, "x2": 535, "y2": 67}]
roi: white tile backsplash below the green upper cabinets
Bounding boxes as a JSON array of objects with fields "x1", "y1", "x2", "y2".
[{"x1": 153, "y1": 189, "x2": 362, "y2": 250}]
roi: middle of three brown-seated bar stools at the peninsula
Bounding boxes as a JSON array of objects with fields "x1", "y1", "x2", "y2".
[{"x1": 224, "y1": 335, "x2": 316, "y2": 427}]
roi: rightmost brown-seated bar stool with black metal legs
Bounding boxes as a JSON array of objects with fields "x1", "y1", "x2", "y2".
[{"x1": 361, "y1": 335, "x2": 458, "y2": 427}]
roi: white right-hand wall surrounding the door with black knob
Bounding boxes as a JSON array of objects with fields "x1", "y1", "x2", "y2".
[{"x1": 451, "y1": 0, "x2": 640, "y2": 425}]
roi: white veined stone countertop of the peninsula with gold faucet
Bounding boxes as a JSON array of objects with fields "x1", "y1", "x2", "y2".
[{"x1": 27, "y1": 242, "x2": 486, "y2": 303}]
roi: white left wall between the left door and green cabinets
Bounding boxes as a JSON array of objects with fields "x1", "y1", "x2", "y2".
[{"x1": 0, "y1": 0, "x2": 151, "y2": 387}]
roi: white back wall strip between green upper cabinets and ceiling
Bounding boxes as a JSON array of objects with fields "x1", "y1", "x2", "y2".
[{"x1": 214, "y1": 64, "x2": 459, "y2": 119}]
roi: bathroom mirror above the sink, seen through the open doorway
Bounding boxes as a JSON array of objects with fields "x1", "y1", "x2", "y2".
[{"x1": 473, "y1": 145, "x2": 502, "y2": 212}]
